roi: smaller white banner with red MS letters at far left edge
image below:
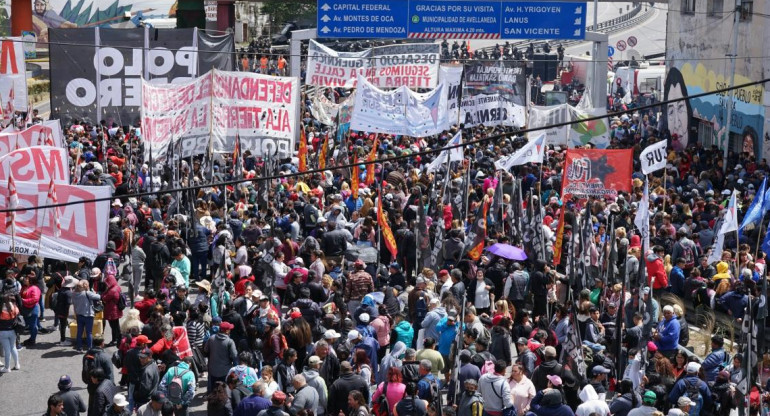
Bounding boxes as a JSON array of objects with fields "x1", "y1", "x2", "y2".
[{"x1": 0, "y1": 146, "x2": 70, "y2": 185}]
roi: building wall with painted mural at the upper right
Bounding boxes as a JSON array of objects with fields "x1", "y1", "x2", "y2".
[{"x1": 664, "y1": 1, "x2": 770, "y2": 155}]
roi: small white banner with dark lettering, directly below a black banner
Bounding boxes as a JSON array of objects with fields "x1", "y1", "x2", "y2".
[{"x1": 460, "y1": 94, "x2": 526, "y2": 127}]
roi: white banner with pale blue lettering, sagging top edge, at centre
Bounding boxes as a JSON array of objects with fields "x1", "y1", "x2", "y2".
[{"x1": 350, "y1": 77, "x2": 449, "y2": 137}]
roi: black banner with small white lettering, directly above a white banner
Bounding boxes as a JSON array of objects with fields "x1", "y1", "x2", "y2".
[{"x1": 463, "y1": 61, "x2": 527, "y2": 106}]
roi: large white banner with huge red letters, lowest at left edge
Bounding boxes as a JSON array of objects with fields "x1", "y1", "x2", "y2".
[{"x1": 0, "y1": 182, "x2": 112, "y2": 262}]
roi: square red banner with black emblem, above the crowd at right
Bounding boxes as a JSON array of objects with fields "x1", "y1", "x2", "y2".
[{"x1": 562, "y1": 149, "x2": 634, "y2": 199}]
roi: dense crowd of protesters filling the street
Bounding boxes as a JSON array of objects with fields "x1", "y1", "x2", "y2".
[{"x1": 0, "y1": 47, "x2": 770, "y2": 416}]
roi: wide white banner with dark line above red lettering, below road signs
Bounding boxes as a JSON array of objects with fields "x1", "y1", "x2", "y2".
[{"x1": 305, "y1": 40, "x2": 441, "y2": 88}]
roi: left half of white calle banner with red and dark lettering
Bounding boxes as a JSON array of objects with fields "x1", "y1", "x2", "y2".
[{"x1": 305, "y1": 39, "x2": 372, "y2": 88}]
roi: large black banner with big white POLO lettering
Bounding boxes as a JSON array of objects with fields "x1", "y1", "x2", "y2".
[{"x1": 49, "y1": 27, "x2": 235, "y2": 125}]
